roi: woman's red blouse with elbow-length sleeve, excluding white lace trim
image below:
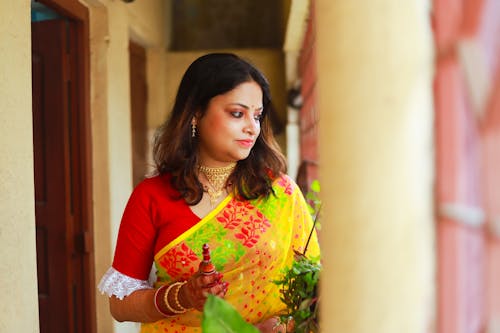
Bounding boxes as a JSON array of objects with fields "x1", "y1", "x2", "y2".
[{"x1": 113, "y1": 174, "x2": 200, "y2": 280}]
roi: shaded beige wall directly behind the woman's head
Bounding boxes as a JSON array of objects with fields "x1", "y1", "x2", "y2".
[{"x1": 163, "y1": 49, "x2": 286, "y2": 152}]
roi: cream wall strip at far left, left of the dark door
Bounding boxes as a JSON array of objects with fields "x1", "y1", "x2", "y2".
[{"x1": 0, "y1": 1, "x2": 38, "y2": 332}]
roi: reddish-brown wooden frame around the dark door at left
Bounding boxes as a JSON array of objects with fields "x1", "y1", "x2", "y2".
[{"x1": 37, "y1": 0, "x2": 97, "y2": 333}]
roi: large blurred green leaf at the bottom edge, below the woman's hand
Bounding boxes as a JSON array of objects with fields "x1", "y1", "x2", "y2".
[{"x1": 201, "y1": 295, "x2": 259, "y2": 333}]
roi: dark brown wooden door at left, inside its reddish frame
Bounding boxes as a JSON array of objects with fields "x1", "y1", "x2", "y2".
[{"x1": 32, "y1": 19, "x2": 92, "y2": 333}]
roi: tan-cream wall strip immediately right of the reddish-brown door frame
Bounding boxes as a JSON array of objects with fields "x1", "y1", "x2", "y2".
[{"x1": 86, "y1": 0, "x2": 117, "y2": 333}]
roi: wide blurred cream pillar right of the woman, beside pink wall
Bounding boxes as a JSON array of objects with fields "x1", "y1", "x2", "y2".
[{"x1": 316, "y1": 0, "x2": 435, "y2": 333}]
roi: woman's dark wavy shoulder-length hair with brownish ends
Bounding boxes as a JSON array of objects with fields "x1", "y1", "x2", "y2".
[{"x1": 153, "y1": 53, "x2": 286, "y2": 205}]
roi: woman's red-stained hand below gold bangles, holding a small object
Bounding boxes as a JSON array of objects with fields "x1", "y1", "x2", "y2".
[{"x1": 179, "y1": 271, "x2": 229, "y2": 311}]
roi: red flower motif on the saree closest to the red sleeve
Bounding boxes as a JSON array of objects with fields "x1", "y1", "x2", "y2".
[{"x1": 160, "y1": 243, "x2": 199, "y2": 279}]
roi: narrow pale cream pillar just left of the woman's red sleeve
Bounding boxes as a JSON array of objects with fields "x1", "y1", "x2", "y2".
[{"x1": 107, "y1": 1, "x2": 139, "y2": 333}]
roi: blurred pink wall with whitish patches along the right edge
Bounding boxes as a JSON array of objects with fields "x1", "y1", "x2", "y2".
[{"x1": 433, "y1": 0, "x2": 500, "y2": 333}]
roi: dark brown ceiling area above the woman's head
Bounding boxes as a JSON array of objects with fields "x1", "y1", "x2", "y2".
[{"x1": 170, "y1": 0, "x2": 290, "y2": 51}]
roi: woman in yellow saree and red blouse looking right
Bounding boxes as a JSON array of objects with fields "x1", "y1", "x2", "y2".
[{"x1": 99, "y1": 53, "x2": 319, "y2": 333}]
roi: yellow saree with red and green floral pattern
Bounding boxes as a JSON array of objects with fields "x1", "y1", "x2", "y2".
[{"x1": 141, "y1": 176, "x2": 319, "y2": 333}]
